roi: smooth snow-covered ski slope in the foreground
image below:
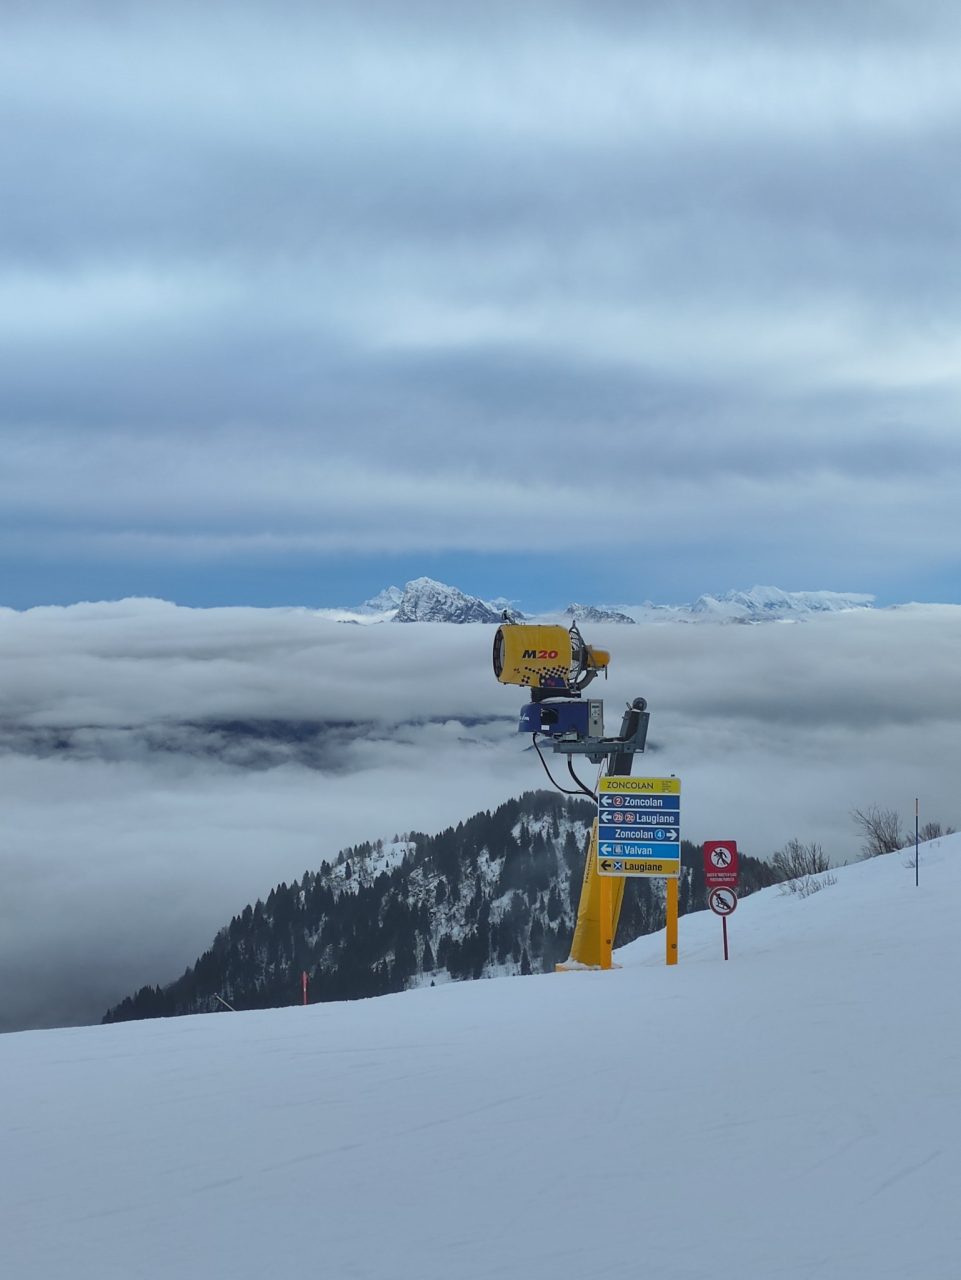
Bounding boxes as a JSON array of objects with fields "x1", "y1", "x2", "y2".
[{"x1": 0, "y1": 836, "x2": 961, "y2": 1280}]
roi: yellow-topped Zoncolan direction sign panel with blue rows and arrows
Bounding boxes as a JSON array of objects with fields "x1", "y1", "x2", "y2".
[{"x1": 598, "y1": 777, "x2": 681, "y2": 876}]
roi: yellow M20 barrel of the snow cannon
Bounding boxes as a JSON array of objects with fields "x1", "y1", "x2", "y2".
[{"x1": 494, "y1": 622, "x2": 610, "y2": 696}]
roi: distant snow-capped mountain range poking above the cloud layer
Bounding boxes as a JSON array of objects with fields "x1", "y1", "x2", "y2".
[{"x1": 319, "y1": 577, "x2": 874, "y2": 625}]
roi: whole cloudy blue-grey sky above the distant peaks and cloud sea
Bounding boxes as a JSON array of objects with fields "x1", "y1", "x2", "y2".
[{"x1": 0, "y1": 0, "x2": 961, "y2": 608}]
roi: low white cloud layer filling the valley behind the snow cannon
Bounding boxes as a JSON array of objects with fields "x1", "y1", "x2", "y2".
[{"x1": 0, "y1": 600, "x2": 961, "y2": 1029}]
